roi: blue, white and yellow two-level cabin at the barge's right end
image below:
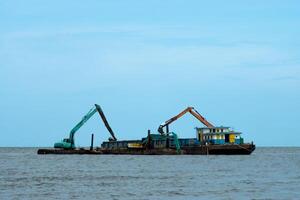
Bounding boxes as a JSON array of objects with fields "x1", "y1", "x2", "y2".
[{"x1": 196, "y1": 126, "x2": 244, "y2": 144}]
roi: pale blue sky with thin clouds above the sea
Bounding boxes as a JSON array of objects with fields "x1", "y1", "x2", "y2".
[{"x1": 0, "y1": 0, "x2": 300, "y2": 147}]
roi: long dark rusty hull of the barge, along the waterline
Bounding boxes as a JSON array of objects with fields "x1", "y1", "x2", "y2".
[{"x1": 37, "y1": 144, "x2": 255, "y2": 155}]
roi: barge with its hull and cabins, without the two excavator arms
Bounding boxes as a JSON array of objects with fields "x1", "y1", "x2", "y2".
[{"x1": 38, "y1": 127, "x2": 255, "y2": 155}]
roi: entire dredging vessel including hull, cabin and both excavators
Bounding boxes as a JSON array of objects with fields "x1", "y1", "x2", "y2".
[{"x1": 37, "y1": 104, "x2": 255, "y2": 155}]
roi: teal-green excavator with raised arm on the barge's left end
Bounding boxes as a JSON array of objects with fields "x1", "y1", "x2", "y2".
[{"x1": 54, "y1": 104, "x2": 117, "y2": 149}]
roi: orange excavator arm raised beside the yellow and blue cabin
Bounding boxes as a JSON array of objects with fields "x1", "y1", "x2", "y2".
[{"x1": 157, "y1": 107, "x2": 214, "y2": 134}]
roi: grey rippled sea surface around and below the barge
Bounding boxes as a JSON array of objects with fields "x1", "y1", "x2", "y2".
[{"x1": 0, "y1": 148, "x2": 300, "y2": 200}]
